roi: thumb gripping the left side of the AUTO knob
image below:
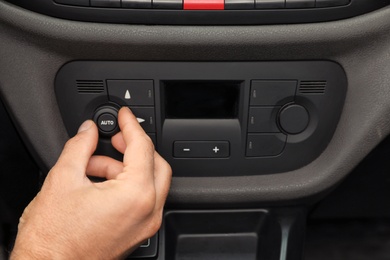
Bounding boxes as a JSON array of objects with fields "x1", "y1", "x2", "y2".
[{"x1": 54, "y1": 120, "x2": 98, "y2": 177}]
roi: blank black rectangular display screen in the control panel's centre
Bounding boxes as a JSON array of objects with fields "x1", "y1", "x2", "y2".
[{"x1": 162, "y1": 81, "x2": 242, "y2": 119}]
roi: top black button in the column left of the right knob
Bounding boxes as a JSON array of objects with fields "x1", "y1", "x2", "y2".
[{"x1": 250, "y1": 80, "x2": 297, "y2": 106}]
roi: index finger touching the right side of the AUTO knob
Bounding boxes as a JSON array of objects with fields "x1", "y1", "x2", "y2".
[{"x1": 118, "y1": 108, "x2": 154, "y2": 181}]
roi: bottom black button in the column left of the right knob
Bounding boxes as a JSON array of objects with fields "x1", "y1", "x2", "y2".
[{"x1": 246, "y1": 134, "x2": 287, "y2": 157}]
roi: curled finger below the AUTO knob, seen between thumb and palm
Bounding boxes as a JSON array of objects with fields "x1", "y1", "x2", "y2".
[{"x1": 87, "y1": 155, "x2": 123, "y2": 180}]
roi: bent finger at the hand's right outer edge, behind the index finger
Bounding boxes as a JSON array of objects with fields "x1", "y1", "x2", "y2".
[{"x1": 154, "y1": 152, "x2": 172, "y2": 210}]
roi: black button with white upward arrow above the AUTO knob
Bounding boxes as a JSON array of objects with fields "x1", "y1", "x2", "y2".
[{"x1": 107, "y1": 80, "x2": 154, "y2": 106}]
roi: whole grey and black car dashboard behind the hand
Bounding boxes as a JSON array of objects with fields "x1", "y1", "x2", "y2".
[{"x1": 0, "y1": 0, "x2": 390, "y2": 260}]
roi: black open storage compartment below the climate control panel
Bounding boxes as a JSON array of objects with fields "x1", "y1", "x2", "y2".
[{"x1": 164, "y1": 210, "x2": 282, "y2": 260}]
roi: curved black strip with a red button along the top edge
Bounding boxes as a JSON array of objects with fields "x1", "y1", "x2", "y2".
[{"x1": 4, "y1": 0, "x2": 389, "y2": 25}]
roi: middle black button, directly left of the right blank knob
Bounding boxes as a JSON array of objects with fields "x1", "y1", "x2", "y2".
[{"x1": 248, "y1": 107, "x2": 280, "y2": 133}]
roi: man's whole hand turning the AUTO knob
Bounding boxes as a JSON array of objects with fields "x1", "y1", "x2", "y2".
[{"x1": 11, "y1": 108, "x2": 171, "y2": 259}]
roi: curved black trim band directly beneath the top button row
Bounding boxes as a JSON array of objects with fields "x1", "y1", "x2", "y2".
[{"x1": 3, "y1": 0, "x2": 389, "y2": 25}]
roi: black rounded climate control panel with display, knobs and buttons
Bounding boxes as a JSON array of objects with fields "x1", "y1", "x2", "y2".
[{"x1": 55, "y1": 61, "x2": 347, "y2": 177}]
